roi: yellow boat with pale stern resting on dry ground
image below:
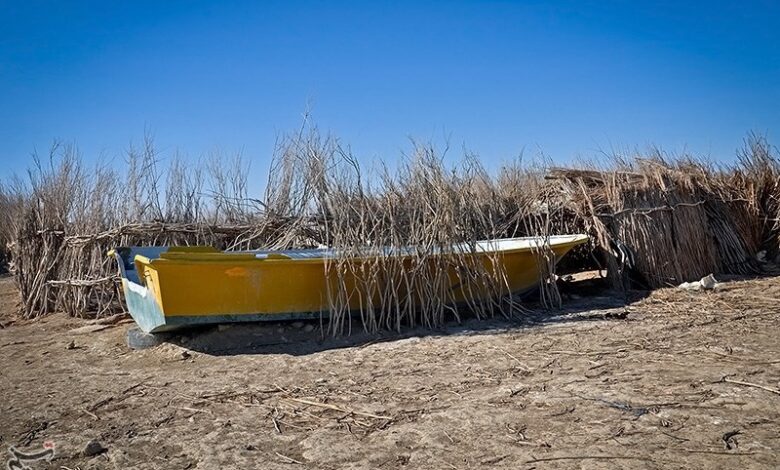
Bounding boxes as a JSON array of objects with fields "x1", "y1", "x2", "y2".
[{"x1": 115, "y1": 235, "x2": 587, "y2": 333}]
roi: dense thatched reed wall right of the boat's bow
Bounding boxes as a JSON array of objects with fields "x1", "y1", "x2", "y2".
[{"x1": 552, "y1": 166, "x2": 761, "y2": 288}]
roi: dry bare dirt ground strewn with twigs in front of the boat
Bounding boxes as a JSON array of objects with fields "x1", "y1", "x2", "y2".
[{"x1": 0, "y1": 277, "x2": 780, "y2": 470}]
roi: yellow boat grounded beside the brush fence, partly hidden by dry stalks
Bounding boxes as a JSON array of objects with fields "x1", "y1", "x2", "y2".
[{"x1": 109, "y1": 235, "x2": 588, "y2": 333}]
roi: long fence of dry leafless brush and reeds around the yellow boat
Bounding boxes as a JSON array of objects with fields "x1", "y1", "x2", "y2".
[{"x1": 0, "y1": 126, "x2": 780, "y2": 333}]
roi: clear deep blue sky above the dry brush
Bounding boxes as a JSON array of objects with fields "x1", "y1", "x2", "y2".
[{"x1": 0, "y1": 0, "x2": 780, "y2": 175}]
